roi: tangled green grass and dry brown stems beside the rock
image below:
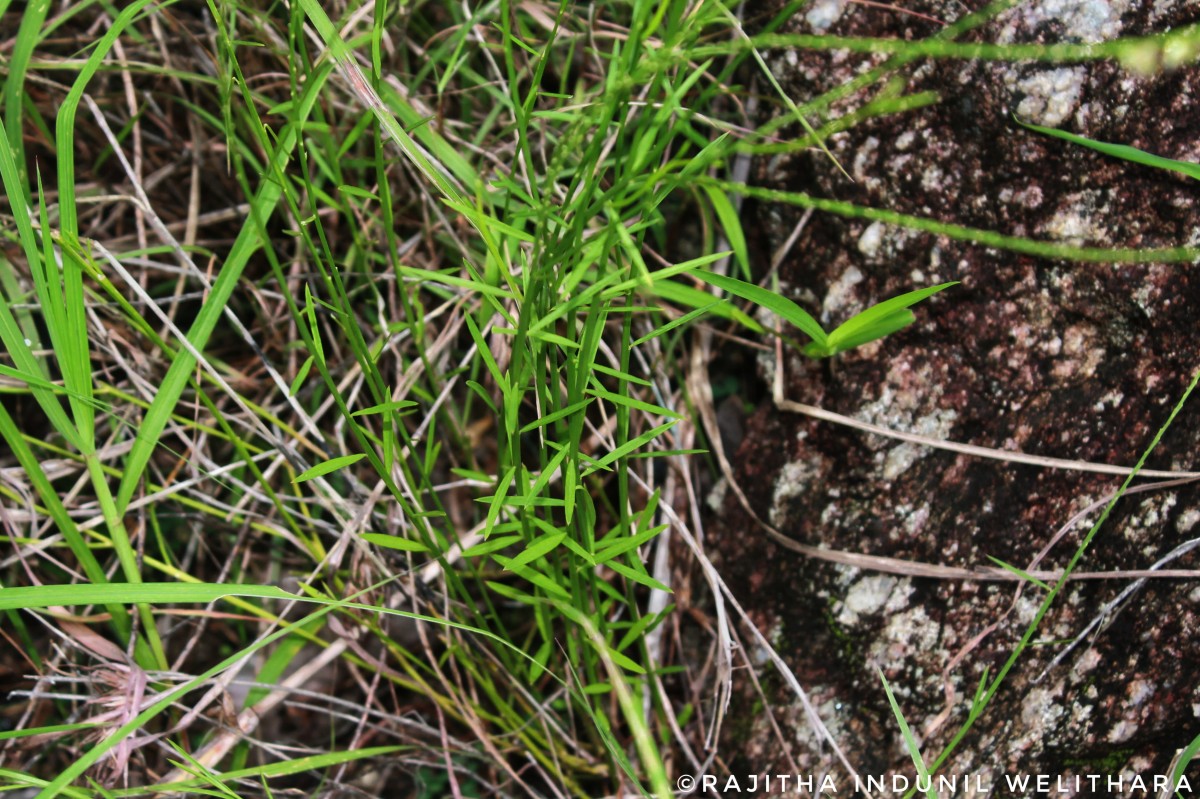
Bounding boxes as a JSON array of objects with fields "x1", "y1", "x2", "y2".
[{"x1": 0, "y1": 2, "x2": 772, "y2": 797}]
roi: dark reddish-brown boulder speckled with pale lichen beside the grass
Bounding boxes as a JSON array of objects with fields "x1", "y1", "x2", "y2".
[{"x1": 712, "y1": 0, "x2": 1200, "y2": 782}]
